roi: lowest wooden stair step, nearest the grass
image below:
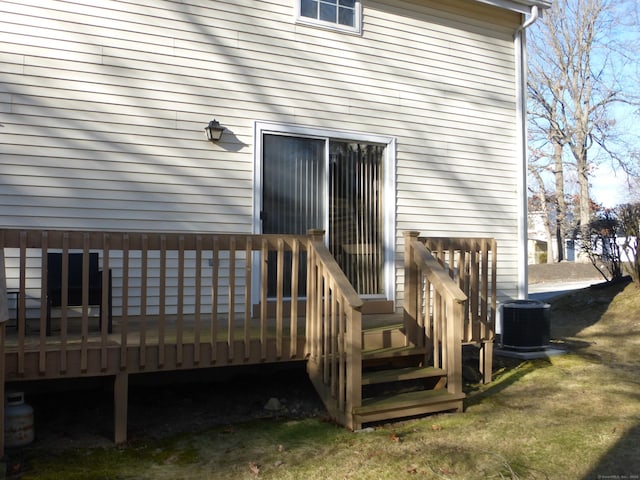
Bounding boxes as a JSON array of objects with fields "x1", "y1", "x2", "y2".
[{"x1": 353, "y1": 390, "x2": 465, "y2": 424}]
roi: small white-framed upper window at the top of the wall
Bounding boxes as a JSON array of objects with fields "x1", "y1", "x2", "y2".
[{"x1": 298, "y1": 0, "x2": 361, "y2": 33}]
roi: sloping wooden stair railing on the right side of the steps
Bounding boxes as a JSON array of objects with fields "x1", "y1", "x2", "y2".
[{"x1": 404, "y1": 232, "x2": 467, "y2": 394}]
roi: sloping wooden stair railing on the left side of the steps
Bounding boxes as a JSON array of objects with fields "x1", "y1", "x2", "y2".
[{"x1": 306, "y1": 230, "x2": 364, "y2": 429}]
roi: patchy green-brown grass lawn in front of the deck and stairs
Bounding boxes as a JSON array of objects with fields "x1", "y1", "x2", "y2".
[{"x1": 9, "y1": 284, "x2": 640, "y2": 480}]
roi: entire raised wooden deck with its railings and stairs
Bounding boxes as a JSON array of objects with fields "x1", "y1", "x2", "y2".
[{"x1": 0, "y1": 230, "x2": 496, "y2": 454}]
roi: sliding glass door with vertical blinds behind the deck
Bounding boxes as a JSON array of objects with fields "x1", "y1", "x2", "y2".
[{"x1": 260, "y1": 133, "x2": 387, "y2": 296}]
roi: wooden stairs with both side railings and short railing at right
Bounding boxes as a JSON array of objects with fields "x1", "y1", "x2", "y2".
[{"x1": 307, "y1": 232, "x2": 496, "y2": 430}]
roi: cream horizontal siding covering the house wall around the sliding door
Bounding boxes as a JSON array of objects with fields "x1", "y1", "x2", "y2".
[{"x1": 0, "y1": 0, "x2": 519, "y2": 297}]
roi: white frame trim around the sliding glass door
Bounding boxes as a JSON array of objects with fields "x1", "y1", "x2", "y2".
[{"x1": 252, "y1": 121, "x2": 397, "y2": 301}]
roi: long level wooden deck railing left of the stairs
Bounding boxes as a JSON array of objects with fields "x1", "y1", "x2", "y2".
[{"x1": 0, "y1": 230, "x2": 316, "y2": 381}]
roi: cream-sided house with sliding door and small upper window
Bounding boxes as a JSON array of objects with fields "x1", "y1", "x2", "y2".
[{"x1": 0, "y1": 0, "x2": 550, "y2": 450}]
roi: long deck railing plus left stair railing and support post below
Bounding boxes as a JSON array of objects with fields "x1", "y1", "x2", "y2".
[{"x1": 0, "y1": 229, "x2": 362, "y2": 455}]
